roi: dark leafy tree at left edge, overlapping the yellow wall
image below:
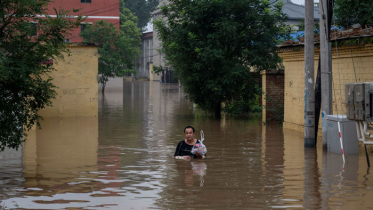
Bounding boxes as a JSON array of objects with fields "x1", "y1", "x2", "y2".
[{"x1": 0, "y1": 0, "x2": 82, "y2": 151}]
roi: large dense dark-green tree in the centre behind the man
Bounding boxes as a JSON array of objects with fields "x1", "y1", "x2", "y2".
[{"x1": 155, "y1": 0, "x2": 289, "y2": 117}]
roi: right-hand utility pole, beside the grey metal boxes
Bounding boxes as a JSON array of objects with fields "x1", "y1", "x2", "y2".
[{"x1": 320, "y1": 0, "x2": 333, "y2": 149}]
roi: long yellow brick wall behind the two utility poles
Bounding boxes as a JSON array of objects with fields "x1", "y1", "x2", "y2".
[{"x1": 279, "y1": 44, "x2": 373, "y2": 131}]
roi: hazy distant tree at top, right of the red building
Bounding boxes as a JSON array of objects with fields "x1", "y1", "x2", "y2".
[{"x1": 121, "y1": 0, "x2": 159, "y2": 31}]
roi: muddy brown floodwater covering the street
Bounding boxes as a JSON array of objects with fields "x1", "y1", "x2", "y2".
[{"x1": 0, "y1": 82, "x2": 373, "y2": 209}]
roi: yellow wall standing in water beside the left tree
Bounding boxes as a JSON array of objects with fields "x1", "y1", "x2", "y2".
[{"x1": 39, "y1": 44, "x2": 99, "y2": 117}]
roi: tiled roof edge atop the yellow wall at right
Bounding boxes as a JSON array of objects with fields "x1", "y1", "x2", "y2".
[{"x1": 278, "y1": 27, "x2": 373, "y2": 47}]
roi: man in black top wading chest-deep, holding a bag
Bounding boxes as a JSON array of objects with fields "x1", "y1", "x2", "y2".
[{"x1": 173, "y1": 126, "x2": 207, "y2": 160}]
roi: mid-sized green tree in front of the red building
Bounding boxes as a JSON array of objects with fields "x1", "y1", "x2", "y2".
[{"x1": 80, "y1": 4, "x2": 141, "y2": 93}]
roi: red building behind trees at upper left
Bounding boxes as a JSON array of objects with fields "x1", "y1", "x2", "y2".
[{"x1": 48, "y1": 0, "x2": 119, "y2": 42}]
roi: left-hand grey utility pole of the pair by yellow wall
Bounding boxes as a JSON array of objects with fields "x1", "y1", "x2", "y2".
[{"x1": 304, "y1": 0, "x2": 316, "y2": 147}]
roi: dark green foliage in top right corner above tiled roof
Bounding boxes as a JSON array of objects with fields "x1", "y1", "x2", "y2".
[{"x1": 333, "y1": 0, "x2": 373, "y2": 27}]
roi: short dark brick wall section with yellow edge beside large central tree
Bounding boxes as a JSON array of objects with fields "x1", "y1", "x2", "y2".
[{"x1": 261, "y1": 70, "x2": 284, "y2": 123}]
